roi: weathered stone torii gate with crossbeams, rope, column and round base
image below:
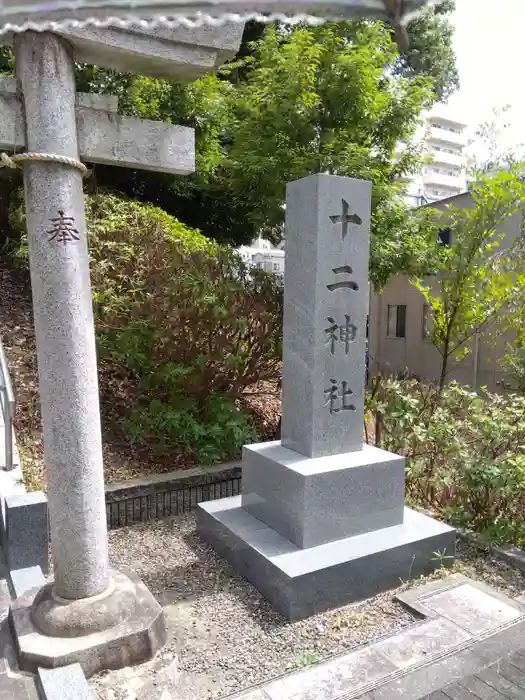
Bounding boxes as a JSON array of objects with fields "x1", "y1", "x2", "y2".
[{"x1": 0, "y1": 25, "x2": 242, "y2": 675}]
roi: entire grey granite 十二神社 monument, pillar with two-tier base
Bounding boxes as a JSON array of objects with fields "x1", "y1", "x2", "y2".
[{"x1": 197, "y1": 175, "x2": 455, "y2": 620}]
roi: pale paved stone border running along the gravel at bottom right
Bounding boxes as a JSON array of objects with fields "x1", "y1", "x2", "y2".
[{"x1": 226, "y1": 574, "x2": 525, "y2": 700}]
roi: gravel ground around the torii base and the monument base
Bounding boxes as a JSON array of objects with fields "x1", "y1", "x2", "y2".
[{"x1": 91, "y1": 515, "x2": 525, "y2": 700}]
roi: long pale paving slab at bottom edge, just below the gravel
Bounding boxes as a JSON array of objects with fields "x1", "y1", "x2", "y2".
[{"x1": 264, "y1": 647, "x2": 395, "y2": 700}]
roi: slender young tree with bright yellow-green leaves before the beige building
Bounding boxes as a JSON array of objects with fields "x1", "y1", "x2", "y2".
[{"x1": 413, "y1": 169, "x2": 525, "y2": 391}]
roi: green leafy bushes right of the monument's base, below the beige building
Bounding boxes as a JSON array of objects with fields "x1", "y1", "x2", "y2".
[{"x1": 368, "y1": 377, "x2": 525, "y2": 543}]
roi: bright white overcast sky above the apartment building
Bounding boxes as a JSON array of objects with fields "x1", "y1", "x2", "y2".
[{"x1": 449, "y1": 0, "x2": 525, "y2": 152}]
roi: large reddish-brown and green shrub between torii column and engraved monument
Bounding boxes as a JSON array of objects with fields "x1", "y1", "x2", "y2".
[{"x1": 12, "y1": 194, "x2": 282, "y2": 463}]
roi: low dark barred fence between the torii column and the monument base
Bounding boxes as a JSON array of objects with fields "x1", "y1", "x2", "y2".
[{"x1": 106, "y1": 476, "x2": 241, "y2": 530}]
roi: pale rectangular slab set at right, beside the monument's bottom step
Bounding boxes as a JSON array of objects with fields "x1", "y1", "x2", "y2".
[{"x1": 425, "y1": 583, "x2": 522, "y2": 634}]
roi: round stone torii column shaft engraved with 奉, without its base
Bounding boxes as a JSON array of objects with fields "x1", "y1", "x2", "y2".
[{"x1": 15, "y1": 32, "x2": 109, "y2": 599}]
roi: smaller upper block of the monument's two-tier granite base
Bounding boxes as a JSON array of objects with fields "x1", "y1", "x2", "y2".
[{"x1": 242, "y1": 442, "x2": 405, "y2": 549}]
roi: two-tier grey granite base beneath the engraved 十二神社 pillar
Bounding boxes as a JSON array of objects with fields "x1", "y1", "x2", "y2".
[{"x1": 197, "y1": 443, "x2": 455, "y2": 620}]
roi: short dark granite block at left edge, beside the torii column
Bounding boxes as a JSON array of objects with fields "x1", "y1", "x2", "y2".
[{"x1": 4, "y1": 491, "x2": 49, "y2": 574}]
